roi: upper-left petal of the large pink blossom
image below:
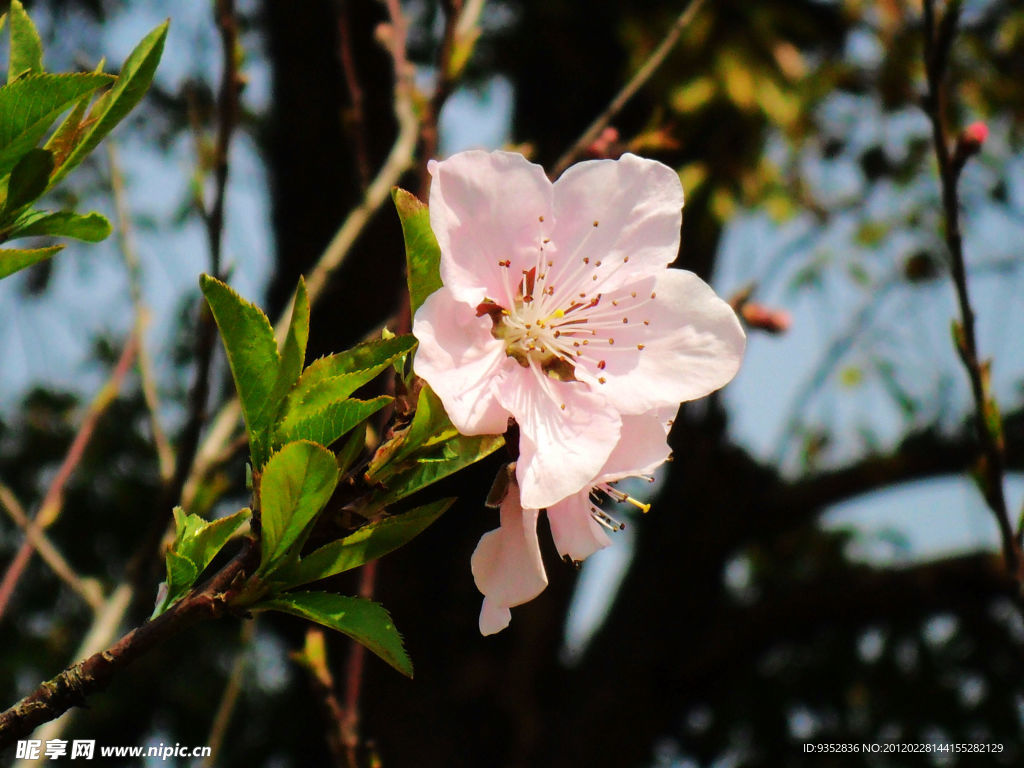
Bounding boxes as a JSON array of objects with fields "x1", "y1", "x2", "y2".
[{"x1": 428, "y1": 151, "x2": 554, "y2": 308}]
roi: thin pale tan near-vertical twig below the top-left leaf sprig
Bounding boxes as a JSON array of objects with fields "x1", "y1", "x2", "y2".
[{"x1": 106, "y1": 140, "x2": 174, "y2": 482}]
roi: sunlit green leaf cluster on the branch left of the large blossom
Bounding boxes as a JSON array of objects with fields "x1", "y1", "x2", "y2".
[{"x1": 157, "y1": 189, "x2": 503, "y2": 676}]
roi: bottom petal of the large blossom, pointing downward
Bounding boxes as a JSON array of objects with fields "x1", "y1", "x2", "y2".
[{"x1": 496, "y1": 366, "x2": 622, "y2": 509}]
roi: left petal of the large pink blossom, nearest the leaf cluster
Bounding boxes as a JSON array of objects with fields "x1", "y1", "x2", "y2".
[{"x1": 413, "y1": 286, "x2": 515, "y2": 435}]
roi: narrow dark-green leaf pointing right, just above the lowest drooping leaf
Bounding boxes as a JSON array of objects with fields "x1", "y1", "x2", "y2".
[{"x1": 279, "y1": 499, "x2": 455, "y2": 590}]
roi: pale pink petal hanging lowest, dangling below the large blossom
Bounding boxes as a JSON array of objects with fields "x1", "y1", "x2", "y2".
[{"x1": 470, "y1": 486, "x2": 548, "y2": 635}]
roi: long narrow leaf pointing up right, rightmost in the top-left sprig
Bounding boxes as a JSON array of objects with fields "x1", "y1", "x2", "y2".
[{"x1": 50, "y1": 22, "x2": 170, "y2": 186}]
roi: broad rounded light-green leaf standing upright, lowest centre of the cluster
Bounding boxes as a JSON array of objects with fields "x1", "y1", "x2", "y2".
[{"x1": 259, "y1": 441, "x2": 338, "y2": 573}]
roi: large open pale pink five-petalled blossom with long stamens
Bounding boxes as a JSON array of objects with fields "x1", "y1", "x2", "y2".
[{"x1": 413, "y1": 152, "x2": 744, "y2": 512}]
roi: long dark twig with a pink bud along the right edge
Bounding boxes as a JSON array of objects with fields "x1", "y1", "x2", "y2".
[{"x1": 924, "y1": 0, "x2": 1024, "y2": 582}]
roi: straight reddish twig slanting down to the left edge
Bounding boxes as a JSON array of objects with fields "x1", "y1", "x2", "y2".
[{"x1": 0, "y1": 333, "x2": 138, "y2": 617}]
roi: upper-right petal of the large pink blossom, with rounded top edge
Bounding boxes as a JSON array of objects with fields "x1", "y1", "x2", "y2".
[{"x1": 551, "y1": 154, "x2": 683, "y2": 291}]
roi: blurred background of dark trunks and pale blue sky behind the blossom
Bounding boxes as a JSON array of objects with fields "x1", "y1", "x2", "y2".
[{"x1": 0, "y1": 0, "x2": 1024, "y2": 768}]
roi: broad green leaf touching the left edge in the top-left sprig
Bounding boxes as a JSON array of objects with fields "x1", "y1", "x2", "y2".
[{"x1": 0, "y1": 74, "x2": 113, "y2": 174}]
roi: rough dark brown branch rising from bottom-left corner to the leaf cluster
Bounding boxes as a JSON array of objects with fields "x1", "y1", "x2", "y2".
[{"x1": 0, "y1": 539, "x2": 258, "y2": 749}]
